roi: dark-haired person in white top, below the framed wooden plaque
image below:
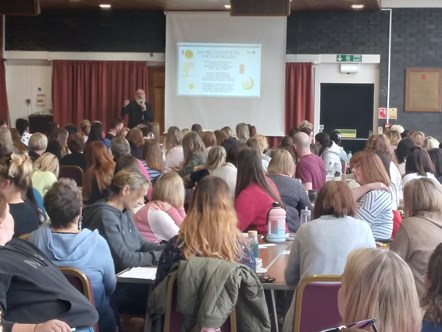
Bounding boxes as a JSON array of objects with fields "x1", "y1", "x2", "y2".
[{"x1": 402, "y1": 146, "x2": 439, "y2": 186}]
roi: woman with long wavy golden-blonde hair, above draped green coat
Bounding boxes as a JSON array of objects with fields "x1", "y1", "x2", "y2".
[{"x1": 156, "y1": 176, "x2": 255, "y2": 284}]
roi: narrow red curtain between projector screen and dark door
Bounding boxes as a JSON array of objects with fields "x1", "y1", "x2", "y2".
[{"x1": 268, "y1": 62, "x2": 314, "y2": 146}]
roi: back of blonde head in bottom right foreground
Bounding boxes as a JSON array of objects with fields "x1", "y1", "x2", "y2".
[{"x1": 338, "y1": 248, "x2": 422, "y2": 332}]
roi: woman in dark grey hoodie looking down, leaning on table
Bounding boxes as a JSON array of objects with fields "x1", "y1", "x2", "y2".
[{"x1": 83, "y1": 169, "x2": 164, "y2": 315}]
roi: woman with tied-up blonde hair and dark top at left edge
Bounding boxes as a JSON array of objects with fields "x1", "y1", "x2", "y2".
[{"x1": 0, "y1": 153, "x2": 40, "y2": 237}]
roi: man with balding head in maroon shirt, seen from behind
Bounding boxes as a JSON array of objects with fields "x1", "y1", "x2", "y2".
[{"x1": 293, "y1": 131, "x2": 326, "y2": 191}]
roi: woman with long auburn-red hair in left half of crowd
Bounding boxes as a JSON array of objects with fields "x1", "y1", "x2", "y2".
[{"x1": 83, "y1": 142, "x2": 115, "y2": 204}]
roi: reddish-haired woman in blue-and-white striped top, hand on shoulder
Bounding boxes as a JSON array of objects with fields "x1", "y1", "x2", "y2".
[{"x1": 350, "y1": 151, "x2": 393, "y2": 239}]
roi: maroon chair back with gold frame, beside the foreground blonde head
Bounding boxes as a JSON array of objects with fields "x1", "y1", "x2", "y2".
[{"x1": 293, "y1": 275, "x2": 341, "y2": 332}]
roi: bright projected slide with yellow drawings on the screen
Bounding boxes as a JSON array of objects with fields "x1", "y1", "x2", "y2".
[{"x1": 177, "y1": 43, "x2": 261, "y2": 97}]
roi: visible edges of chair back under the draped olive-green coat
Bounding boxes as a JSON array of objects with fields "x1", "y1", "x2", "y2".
[{"x1": 163, "y1": 274, "x2": 236, "y2": 332}]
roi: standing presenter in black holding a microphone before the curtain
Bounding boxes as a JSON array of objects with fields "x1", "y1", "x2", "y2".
[{"x1": 121, "y1": 89, "x2": 153, "y2": 128}]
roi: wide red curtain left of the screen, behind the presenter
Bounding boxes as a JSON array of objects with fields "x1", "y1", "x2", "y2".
[{"x1": 52, "y1": 60, "x2": 148, "y2": 130}]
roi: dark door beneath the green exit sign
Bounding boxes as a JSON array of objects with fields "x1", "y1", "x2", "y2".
[{"x1": 319, "y1": 83, "x2": 374, "y2": 153}]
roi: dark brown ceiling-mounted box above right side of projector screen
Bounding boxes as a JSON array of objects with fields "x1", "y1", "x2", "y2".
[{"x1": 230, "y1": 0, "x2": 290, "y2": 16}]
